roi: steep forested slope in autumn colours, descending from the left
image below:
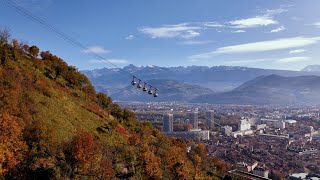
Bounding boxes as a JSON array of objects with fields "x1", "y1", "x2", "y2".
[{"x1": 0, "y1": 31, "x2": 227, "y2": 179}]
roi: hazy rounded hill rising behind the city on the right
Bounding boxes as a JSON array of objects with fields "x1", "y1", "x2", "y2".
[{"x1": 193, "y1": 75, "x2": 320, "y2": 106}]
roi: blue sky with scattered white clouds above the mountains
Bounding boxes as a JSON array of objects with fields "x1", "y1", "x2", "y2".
[{"x1": 0, "y1": 0, "x2": 320, "y2": 70}]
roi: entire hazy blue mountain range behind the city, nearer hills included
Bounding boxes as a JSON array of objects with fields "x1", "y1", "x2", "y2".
[{"x1": 82, "y1": 65, "x2": 320, "y2": 104}]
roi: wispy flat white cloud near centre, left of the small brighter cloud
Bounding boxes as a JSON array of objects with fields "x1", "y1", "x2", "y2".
[{"x1": 139, "y1": 23, "x2": 202, "y2": 39}]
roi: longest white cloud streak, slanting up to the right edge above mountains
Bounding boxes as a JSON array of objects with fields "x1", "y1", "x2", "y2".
[{"x1": 190, "y1": 36, "x2": 320, "y2": 59}]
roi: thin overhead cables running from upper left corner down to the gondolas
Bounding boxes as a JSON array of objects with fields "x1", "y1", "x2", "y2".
[{"x1": 3, "y1": 0, "x2": 158, "y2": 94}]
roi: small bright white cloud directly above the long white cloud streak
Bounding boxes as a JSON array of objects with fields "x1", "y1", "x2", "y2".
[{"x1": 229, "y1": 16, "x2": 278, "y2": 29}]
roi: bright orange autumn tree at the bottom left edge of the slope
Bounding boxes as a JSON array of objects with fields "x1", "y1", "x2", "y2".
[{"x1": 0, "y1": 113, "x2": 25, "y2": 176}]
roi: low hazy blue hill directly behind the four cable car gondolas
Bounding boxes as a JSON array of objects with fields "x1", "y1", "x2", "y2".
[{"x1": 113, "y1": 79, "x2": 213, "y2": 102}]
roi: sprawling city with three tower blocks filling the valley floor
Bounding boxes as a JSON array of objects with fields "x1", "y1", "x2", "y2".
[{"x1": 120, "y1": 102, "x2": 320, "y2": 178}]
